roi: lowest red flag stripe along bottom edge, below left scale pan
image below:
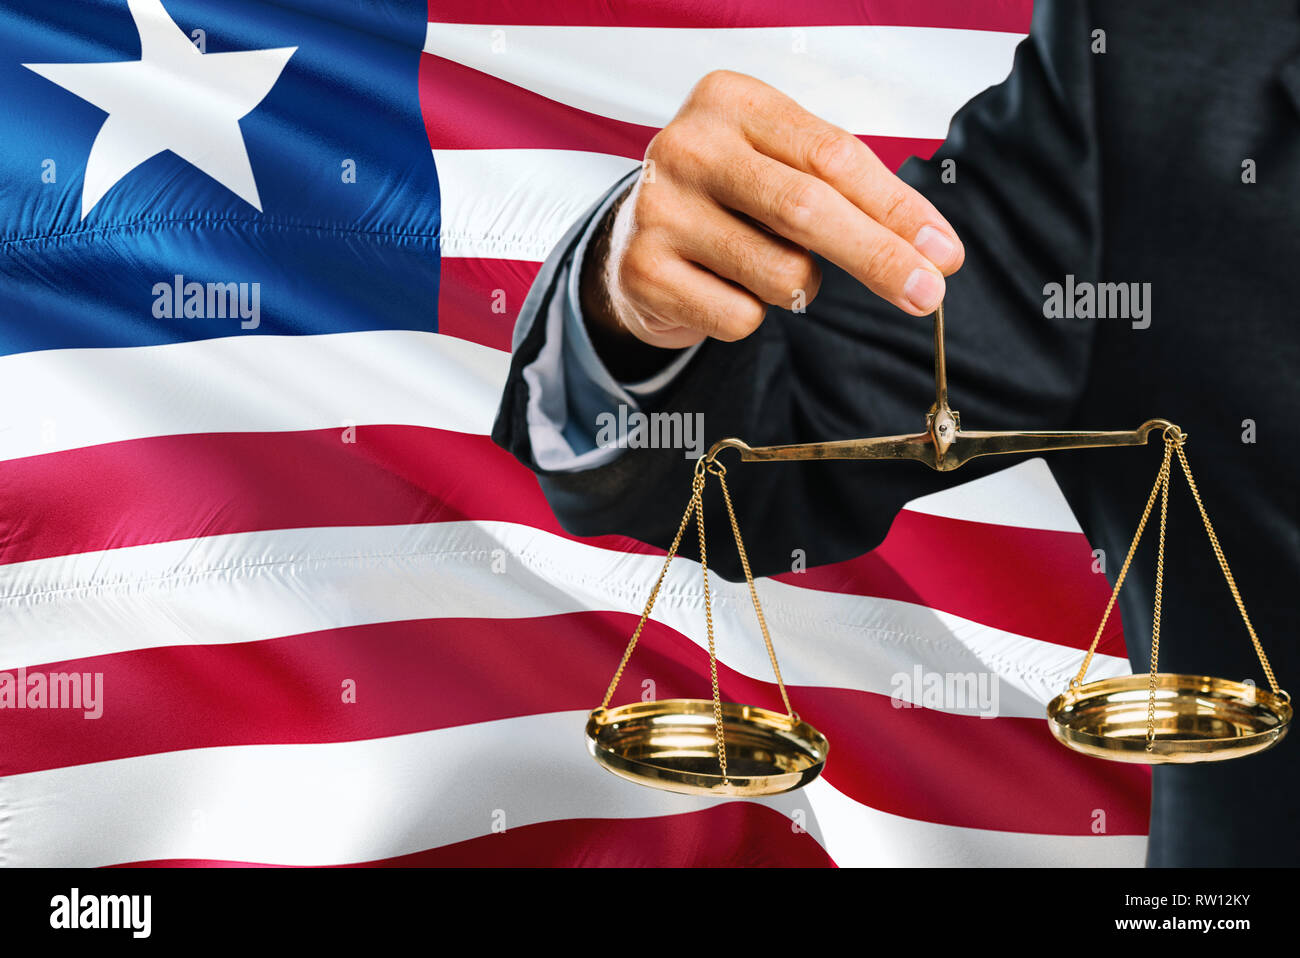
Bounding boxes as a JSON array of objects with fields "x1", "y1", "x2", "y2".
[{"x1": 116, "y1": 802, "x2": 835, "y2": 868}]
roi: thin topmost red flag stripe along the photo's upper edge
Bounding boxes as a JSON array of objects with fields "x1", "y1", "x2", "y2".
[{"x1": 429, "y1": 0, "x2": 1034, "y2": 34}]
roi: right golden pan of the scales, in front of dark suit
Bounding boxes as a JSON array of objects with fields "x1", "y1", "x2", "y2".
[{"x1": 1048, "y1": 672, "x2": 1291, "y2": 766}]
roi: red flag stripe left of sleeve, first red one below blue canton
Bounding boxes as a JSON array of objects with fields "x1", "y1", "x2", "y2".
[{"x1": 0, "y1": 425, "x2": 655, "y2": 563}]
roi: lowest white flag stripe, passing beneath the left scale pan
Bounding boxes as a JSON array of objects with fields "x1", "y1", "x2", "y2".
[{"x1": 0, "y1": 711, "x2": 1147, "y2": 867}]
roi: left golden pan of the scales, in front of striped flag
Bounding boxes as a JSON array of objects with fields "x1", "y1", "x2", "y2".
[{"x1": 586, "y1": 698, "x2": 829, "y2": 796}]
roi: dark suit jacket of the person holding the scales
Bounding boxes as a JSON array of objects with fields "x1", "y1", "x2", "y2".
[{"x1": 493, "y1": 0, "x2": 1300, "y2": 866}]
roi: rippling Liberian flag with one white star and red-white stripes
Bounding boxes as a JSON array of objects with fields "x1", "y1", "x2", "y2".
[{"x1": 0, "y1": 0, "x2": 1149, "y2": 866}]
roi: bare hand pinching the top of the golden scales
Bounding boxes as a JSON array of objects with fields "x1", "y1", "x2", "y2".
[{"x1": 598, "y1": 71, "x2": 965, "y2": 347}]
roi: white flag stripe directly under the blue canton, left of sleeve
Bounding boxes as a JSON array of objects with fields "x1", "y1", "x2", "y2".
[{"x1": 0, "y1": 330, "x2": 510, "y2": 460}]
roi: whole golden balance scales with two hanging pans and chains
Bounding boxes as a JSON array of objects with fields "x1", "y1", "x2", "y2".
[{"x1": 586, "y1": 304, "x2": 1291, "y2": 796}]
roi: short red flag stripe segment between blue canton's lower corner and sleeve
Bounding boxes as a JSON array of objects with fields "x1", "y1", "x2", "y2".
[{"x1": 438, "y1": 256, "x2": 541, "y2": 352}]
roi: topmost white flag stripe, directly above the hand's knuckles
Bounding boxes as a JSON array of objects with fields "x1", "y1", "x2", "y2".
[{"x1": 424, "y1": 23, "x2": 1023, "y2": 139}]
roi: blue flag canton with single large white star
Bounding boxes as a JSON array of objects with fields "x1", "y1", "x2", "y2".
[{"x1": 0, "y1": 0, "x2": 439, "y2": 354}]
